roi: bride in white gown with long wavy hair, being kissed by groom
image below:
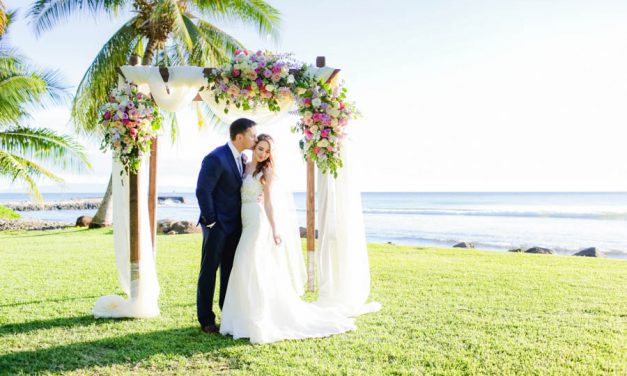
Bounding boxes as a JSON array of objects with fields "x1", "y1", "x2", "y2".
[{"x1": 220, "y1": 134, "x2": 355, "y2": 343}]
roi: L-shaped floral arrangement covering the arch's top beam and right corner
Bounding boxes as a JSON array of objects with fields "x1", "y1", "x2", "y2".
[{"x1": 209, "y1": 50, "x2": 359, "y2": 177}]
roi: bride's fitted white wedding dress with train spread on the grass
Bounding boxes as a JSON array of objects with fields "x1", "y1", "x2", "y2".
[{"x1": 220, "y1": 174, "x2": 355, "y2": 343}]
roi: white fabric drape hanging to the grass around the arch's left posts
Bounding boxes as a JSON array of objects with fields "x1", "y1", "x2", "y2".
[{"x1": 92, "y1": 156, "x2": 159, "y2": 318}]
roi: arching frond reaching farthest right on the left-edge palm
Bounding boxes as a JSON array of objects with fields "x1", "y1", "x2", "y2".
[{"x1": 0, "y1": 126, "x2": 91, "y2": 171}]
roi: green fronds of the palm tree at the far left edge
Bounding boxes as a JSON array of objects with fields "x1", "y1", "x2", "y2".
[{"x1": 0, "y1": 13, "x2": 89, "y2": 202}]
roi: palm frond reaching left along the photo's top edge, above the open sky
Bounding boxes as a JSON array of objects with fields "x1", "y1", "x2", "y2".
[{"x1": 28, "y1": 0, "x2": 128, "y2": 36}]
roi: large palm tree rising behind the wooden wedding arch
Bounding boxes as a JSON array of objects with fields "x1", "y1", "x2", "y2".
[{"x1": 30, "y1": 0, "x2": 279, "y2": 226}]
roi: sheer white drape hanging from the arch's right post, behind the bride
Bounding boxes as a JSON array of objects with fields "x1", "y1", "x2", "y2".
[{"x1": 316, "y1": 140, "x2": 381, "y2": 316}]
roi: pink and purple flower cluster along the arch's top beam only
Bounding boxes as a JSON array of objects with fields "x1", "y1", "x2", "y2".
[{"x1": 212, "y1": 50, "x2": 300, "y2": 112}]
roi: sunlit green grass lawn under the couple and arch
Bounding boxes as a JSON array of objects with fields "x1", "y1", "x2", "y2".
[{"x1": 0, "y1": 229, "x2": 627, "y2": 375}]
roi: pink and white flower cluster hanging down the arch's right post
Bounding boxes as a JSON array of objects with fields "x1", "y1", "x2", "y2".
[{"x1": 294, "y1": 83, "x2": 359, "y2": 177}]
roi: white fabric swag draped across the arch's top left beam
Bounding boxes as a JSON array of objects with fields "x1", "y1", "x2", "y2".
[{"x1": 120, "y1": 65, "x2": 207, "y2": 112}]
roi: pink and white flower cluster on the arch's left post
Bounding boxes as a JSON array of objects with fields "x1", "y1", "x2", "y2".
[{"x1": 100, "y1": 84, "x2": 162, "y2": 174}]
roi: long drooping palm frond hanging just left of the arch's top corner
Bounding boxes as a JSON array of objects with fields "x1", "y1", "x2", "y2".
[{"x1": 72, "y1": 20, "x2": 141, "y2": 138}]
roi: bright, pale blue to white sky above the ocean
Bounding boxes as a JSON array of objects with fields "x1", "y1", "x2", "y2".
[{"x1": 0, "y1": 0, "x2": 627, "y2": 192}]
